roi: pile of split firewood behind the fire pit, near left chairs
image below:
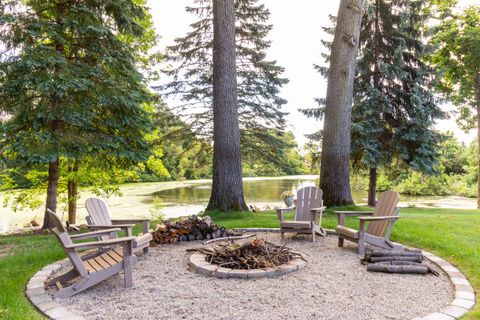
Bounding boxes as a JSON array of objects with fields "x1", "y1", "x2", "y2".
[{"x1": 152, "y1": 215, "x2": 237, "y2": 244}]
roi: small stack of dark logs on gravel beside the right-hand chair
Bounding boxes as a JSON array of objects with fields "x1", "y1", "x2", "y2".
[{"x1": 362, "y1": 250, "x2": 438, "y2": 276}]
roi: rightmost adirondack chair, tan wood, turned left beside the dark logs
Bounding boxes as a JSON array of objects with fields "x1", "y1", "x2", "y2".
[{"x1": 335, "y1": 191, "x2": 403, "y2": 255}]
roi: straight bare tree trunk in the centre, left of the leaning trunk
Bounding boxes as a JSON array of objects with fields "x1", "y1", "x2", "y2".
[{"x1": 207, "y1": 0, "x2": 248, "y2": 211}]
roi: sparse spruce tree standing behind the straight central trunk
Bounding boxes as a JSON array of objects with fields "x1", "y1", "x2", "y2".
[{"x1": 159, "y1": 0, "x2": 288, "y2": 166}]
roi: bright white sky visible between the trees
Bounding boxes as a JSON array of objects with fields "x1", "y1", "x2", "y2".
[{"x1": 148, "y1": 0, "x2": 480, "y2": 146}]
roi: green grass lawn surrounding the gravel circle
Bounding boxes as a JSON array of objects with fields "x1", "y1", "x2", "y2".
[{"x1": 0, "y1": 207, "x2": 480, "y2": 320}]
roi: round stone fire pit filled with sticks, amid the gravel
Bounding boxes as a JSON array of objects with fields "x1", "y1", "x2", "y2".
[{"x1": 187, "y1": 238, "x2": 306, "y2": 279}]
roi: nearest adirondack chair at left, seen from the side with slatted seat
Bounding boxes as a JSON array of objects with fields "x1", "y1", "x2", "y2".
[{"x1": 47, "y1": 209, "x2": 137, "y2": 298}]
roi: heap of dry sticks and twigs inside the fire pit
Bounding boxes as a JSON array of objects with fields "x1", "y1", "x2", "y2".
[{"x1": 187, "y1": 238, "x2": 305, "y2": 269}]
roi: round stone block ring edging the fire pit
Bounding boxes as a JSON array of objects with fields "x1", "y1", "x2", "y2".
[{"x1": 188, "y1": 253, "x2": 307, "y2": 279}]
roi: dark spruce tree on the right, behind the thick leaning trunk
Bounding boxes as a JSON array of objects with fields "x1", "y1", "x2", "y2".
[{"x1": 304, "y1": 0, "x2": 444, "y2": 205}]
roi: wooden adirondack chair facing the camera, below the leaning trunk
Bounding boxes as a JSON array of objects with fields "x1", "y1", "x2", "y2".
[{"x1": 276, "y1": 187, "x2": 327, "y2": 242}]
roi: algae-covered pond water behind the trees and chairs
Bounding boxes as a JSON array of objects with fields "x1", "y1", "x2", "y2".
[{"x1": 0, "y1": 176, "x2": 476, "y2": 233}]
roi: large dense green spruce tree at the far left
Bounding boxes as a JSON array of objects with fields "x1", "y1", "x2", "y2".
[{"x1": 0, "y1": 0, "x2": 150, "y2": 228}]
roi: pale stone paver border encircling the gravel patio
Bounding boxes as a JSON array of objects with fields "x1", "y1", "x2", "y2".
[{"x1": 25, "y1": 228, "x2": 476, "y2": 320}]
